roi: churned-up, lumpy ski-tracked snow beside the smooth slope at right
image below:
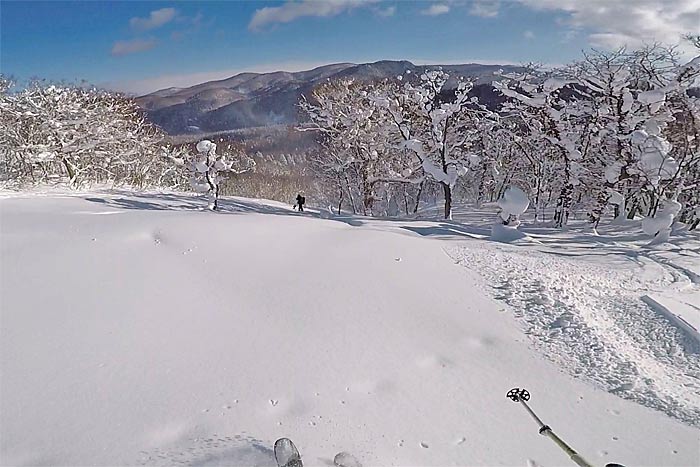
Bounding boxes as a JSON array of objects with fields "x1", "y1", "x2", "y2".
[{"x1": 446, "y1": 243, "x2": 700, "y2": 427}]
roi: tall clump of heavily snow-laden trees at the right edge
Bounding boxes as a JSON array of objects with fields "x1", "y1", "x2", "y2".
[{"x1": 486, "y1": 45, "x2": 700, "y2": 238}]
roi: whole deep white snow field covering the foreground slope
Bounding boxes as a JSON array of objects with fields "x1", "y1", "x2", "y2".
[{"x1": 0, "y1": 191, "x2": 700, "y2": 467}]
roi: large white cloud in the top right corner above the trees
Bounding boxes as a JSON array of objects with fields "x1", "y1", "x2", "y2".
[{"x1": 518, "y1": 0, "x2": 700, "y2": 52}]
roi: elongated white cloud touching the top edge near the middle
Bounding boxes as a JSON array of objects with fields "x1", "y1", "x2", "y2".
[{"x1": 248, "y1": 0, "x2": 377, "y2": 31}]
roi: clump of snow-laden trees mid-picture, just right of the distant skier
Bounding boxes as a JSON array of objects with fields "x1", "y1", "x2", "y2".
[{"x1": 300, "y1": 70, "x2": 488, "y2": 218}]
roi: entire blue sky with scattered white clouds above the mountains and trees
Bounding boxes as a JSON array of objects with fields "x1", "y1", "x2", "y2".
[{"x1": 0, "y1": 0, "x2": 700, "y2": 93}]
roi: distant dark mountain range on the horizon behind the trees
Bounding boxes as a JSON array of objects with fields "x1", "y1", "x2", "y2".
[{"x1": 136, "y1": 61, "x2": 518, "y2": 135}]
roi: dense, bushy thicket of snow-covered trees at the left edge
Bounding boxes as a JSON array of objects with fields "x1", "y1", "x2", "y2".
[{"x1": 0, "y1": 83, "x2": 174, "y2": 186}]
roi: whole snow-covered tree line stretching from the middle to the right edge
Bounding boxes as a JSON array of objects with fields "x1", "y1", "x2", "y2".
[{"x1": 300, "y1": 44, "x2": 700, "y2": 227}]
